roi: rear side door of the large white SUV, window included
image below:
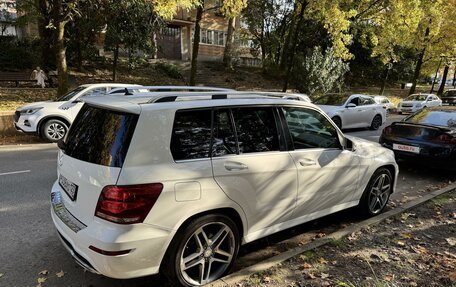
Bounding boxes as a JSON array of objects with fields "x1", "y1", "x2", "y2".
[{"x1": 212, "y1": 107, "x2": 297, "y2": 237}]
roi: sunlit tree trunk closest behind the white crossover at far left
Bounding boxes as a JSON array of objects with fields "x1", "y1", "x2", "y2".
[{"x1": 55, "y1": 21, "x2": 68, "y2": 96}]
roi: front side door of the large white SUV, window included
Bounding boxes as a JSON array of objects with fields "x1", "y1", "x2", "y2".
[{"x1": 283, "y1": 107, "x2": 359, "y2": 218}]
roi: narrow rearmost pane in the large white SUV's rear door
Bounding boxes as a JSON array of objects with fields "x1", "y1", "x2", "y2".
[{"x1": 212, "y1": 110, "x2": 237, "y2": 157}]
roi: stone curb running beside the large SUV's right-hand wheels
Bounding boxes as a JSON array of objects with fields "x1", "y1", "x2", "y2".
[{"x1": 208, "y1": 184, "x2": 456, "y2": 287}]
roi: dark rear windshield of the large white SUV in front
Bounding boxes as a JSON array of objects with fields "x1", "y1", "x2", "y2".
[{"x1": 64, "y1": 104, "x2": 139, "y2": 167}]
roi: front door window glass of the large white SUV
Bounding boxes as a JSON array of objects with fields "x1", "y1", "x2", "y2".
[{"x1": 284, "y1": 108, "x2": 340, "y2": 149}]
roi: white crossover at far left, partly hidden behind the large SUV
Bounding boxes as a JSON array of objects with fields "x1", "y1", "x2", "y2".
[{"x1": 14, "y1": 83, "x2": 138, "y2": 142}]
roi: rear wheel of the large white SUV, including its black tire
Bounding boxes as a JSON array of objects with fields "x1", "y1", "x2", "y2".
[{"x1": 162, "y1": 214, "x2": 240, "y2": 286}]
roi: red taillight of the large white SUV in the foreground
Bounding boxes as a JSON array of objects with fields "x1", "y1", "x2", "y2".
[{"x1": 95, "y1": 183, "x2": 163, "y2": 224}]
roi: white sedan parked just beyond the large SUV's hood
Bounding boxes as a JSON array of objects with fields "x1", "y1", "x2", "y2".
[{"x1": 313, "y1": 94, "x2": 386, "y2": 130}]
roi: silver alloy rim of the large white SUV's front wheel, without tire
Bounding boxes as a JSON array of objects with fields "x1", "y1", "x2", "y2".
[{"x1": 367, "y1": 173, "x2": 391, "y2": 214}]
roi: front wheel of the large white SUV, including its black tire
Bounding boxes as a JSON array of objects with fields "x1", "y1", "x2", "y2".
[{"x1": 358, "y1": 168, "x2": 393, "y2": 217}]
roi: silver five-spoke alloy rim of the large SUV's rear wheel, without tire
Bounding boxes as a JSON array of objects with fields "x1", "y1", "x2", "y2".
[{"x1": 180, "y1": 222, "x2": 236, "y2": 285}]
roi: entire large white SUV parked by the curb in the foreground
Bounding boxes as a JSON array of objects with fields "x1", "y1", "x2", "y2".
[{"x1": 51, "y1": 91, "x2": 398, "y2": 286}]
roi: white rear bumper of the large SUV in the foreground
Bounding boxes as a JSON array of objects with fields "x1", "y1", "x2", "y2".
[{"x1": 51, "y1": 183, "x2": 174, "y2": 279}]
